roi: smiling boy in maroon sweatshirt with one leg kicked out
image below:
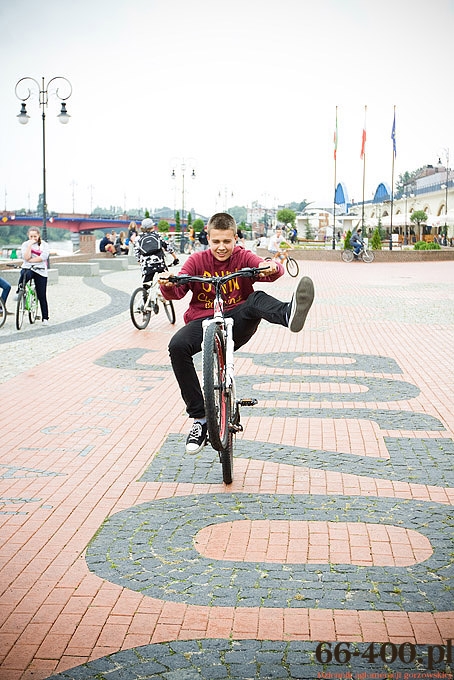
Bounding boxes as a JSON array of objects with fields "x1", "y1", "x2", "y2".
[{"x1": 159, "y1": 213, "x2": 314, "y2": 453}]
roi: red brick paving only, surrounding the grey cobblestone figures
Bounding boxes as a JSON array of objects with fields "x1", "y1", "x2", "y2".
[{"x1": 0, "y1": 262, "x2": 454, "y2": 680}]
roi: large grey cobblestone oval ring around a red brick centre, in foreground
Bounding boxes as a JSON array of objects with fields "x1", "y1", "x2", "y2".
[{"x1": 86, "y1": 494, "x2": 454, "y2": 611}]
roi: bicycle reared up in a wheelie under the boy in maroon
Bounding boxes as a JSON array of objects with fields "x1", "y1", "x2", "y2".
[{"x1": 169, "y1": 267, "x2": 268, "y2": 484}]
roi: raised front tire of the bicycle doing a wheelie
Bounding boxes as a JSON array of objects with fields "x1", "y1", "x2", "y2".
[{"x1": 202, "y1": 323, "x2": 230, "y2": 452}]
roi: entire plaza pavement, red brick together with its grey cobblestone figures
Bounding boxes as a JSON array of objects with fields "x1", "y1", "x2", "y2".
[{"x1": 0, "y1": 261, "x2": 454, "y2": 680}]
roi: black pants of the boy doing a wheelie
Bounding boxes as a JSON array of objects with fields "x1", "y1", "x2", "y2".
[{"x1": 169, "y1": 291, "x2": 289, "y2": 418}]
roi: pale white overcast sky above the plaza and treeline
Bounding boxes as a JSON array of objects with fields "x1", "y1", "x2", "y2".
[{"x1": 0, "y1": 0, "x2": 454, "y2": 215}]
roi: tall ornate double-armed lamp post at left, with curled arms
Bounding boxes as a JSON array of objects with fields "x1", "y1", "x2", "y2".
[{"x1": 15, "y1": 76, "x2": 72, "y2": 241}]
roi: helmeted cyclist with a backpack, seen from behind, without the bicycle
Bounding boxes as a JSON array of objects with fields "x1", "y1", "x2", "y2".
[{"x1": 134, "y1": 217, "x2": 179, "y2": 287}]
